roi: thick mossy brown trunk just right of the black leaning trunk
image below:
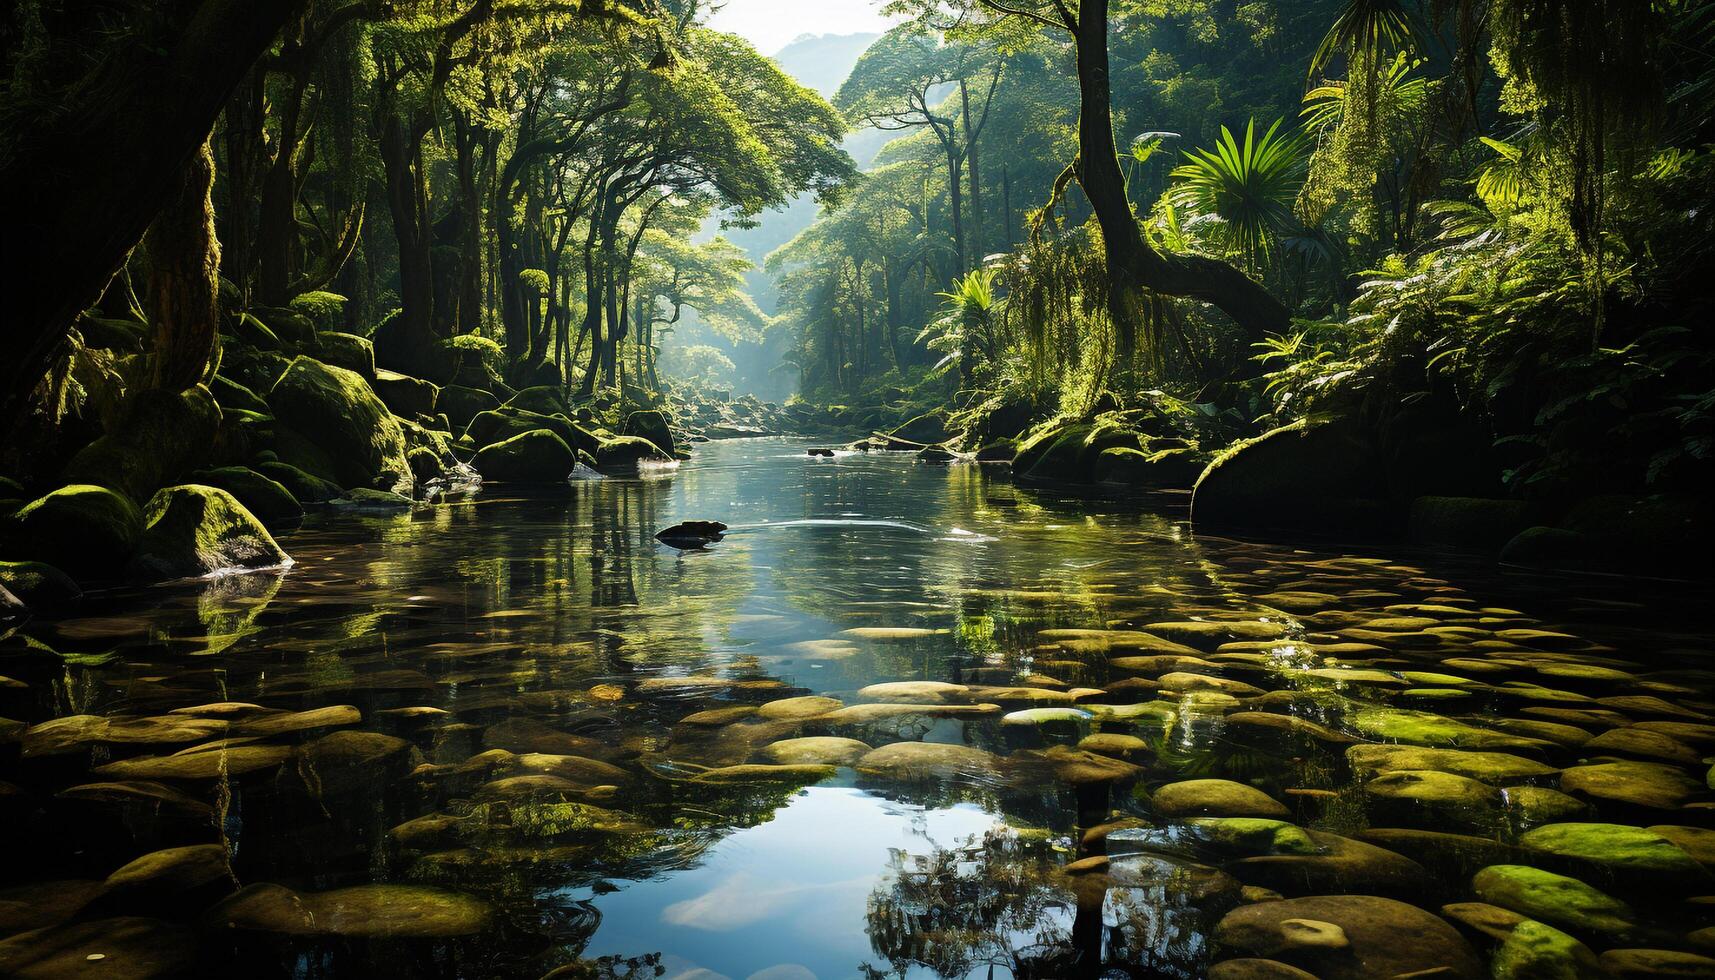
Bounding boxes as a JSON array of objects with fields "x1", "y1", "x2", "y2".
[{"x1": 147, "y1": 139, "x2": 220, "y2": 391}]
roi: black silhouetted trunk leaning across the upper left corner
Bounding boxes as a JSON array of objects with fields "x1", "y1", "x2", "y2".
[{"x1": 0, "y1": 0, "x2": 307, "y2": 431}]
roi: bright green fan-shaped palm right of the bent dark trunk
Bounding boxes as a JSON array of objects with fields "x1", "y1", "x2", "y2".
[{"x1": 1171, "y1": 118, "x2": 1310, "y2": 264}]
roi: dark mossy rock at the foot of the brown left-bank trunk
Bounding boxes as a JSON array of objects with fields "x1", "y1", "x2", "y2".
[{"x1": 62, "y1": 384, "x2": 221, "y2": 501}]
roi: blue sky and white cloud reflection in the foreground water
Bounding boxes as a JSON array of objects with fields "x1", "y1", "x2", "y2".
[{"x1": 568, "y1": 788, "x2": 996, "y2": 980}]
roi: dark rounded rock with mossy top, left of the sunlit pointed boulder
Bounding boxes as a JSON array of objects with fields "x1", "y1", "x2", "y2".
[{"x1": 5, "y1": 484, "x2": 144, "y2": 582}]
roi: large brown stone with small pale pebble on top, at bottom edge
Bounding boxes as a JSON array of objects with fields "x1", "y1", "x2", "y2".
[{"x1": 1214, "y1": 894, "x2": 1487, "y2": 980}]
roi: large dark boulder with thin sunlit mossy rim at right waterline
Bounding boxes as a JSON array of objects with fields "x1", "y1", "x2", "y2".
[{"x1": 1192, "y1": 419, "x2": 1394, "y2": 534}]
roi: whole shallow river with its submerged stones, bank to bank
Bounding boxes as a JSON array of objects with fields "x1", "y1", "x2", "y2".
[{"x1": 0, "y1": 439, "x2": 1715, "y2": 980}]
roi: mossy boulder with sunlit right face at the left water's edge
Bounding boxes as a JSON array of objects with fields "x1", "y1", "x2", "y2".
[{"x1": 130, "y1": 484, "x2": 290, "y2": 582}]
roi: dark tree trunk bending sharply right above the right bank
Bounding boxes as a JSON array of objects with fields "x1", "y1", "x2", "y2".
[{"x1": 1074, "y1": 0, "x2": 1291, "y2": 360}]
